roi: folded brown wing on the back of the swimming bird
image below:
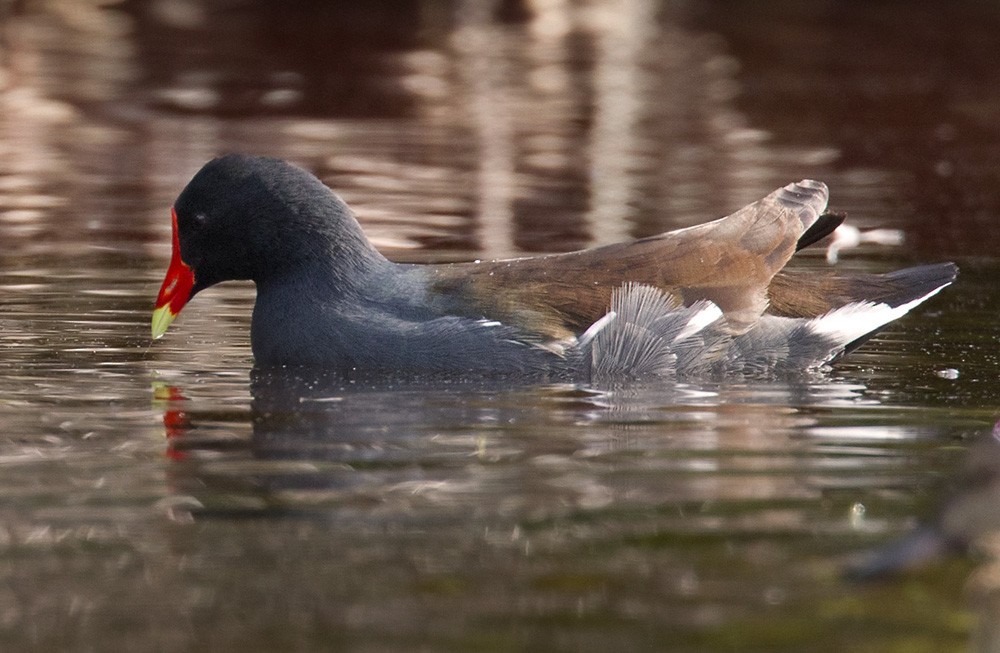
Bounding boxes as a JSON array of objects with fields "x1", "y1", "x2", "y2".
[{"x1": 432, "y1": 180, "x2": 827, "y2": 340}]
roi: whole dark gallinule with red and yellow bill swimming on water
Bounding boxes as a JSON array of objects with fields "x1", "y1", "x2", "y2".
[{"x1": 153, "y1": 154, "x2": 957, "y2": 378}]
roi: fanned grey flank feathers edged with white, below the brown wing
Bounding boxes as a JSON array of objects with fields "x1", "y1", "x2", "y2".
[{"x1": 581, "y1": 283, "x2": 722, "y2": 381}]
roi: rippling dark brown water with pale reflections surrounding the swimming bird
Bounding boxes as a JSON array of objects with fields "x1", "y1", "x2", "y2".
[{"x1": 0, "y1": 0, "x2": 1000, "y2": 651}]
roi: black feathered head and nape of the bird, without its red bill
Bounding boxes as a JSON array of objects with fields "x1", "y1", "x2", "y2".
[{"x1": 174, "y1": 154, "x2": 381, "y2": 295}]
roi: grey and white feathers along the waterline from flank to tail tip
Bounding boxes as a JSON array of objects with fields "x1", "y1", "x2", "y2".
[{"x1": 578, "y1": 268, "x2": 953, "y2": 381}]
